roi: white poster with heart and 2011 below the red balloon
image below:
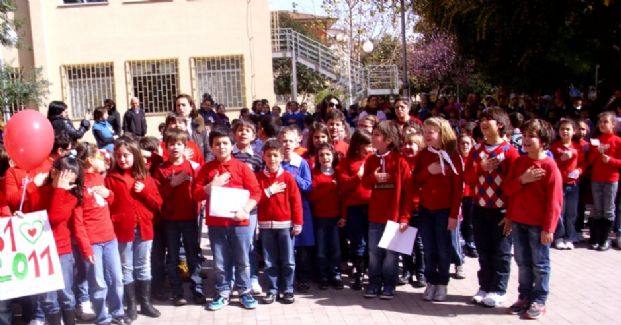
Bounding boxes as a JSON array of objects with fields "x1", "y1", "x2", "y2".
[{"x1": 0, "y1": 211, "x2": 65, "y2": 300}]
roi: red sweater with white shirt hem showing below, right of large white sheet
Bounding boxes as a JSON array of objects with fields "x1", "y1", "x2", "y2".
[{"x1": 255, "y1": 169, "x2": 303, "y2": 229}]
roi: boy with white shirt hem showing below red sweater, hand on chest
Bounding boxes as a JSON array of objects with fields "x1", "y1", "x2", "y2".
[{"x1": 256, "y1": 140, "x2": 303, "y2": 304}]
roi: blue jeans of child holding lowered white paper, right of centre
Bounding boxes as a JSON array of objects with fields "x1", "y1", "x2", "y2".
[{"x1": 369, "y1": 222, "x2": 399, "y2": 292}]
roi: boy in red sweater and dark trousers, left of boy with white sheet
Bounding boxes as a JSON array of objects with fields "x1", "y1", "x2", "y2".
[{"x1": 155, "y1": 129, "x2": 205, "y2": 306}]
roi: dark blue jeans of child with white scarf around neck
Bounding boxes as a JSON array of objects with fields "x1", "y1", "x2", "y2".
[{"x1": 418, "y1": 207, "x2": 452, "y2": 285}]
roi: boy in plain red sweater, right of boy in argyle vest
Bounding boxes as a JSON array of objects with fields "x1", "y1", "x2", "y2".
[{"x1": 503, "y1": 119, "x2": 564, "y2": 319}]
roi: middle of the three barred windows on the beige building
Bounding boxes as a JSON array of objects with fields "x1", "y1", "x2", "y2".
[{"x1": 125, "y1": 59, "x2": 179, "y2": 113}]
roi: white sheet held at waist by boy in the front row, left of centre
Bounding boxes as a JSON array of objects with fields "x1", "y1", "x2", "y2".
[{"x1": 209, "y1": 186, "x2": 250, "y2": 218}]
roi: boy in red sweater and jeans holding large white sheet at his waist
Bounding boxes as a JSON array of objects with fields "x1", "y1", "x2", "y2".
[{"x1": 193, "y1": 129, "x2": 261, "y2": 310}]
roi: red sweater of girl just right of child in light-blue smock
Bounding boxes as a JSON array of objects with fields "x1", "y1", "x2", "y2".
[{"x1": 308, "y1": 168, "x2": 341, "y2": 218}]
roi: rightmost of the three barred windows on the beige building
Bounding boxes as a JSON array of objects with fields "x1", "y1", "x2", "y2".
[{"x1": 190, "y1": 55, "x2": 246, "y2": 107}]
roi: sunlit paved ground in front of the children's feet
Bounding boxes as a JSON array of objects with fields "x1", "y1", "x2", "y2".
[{"x1": 134, "y1": 230, "x2": 621, "y2": 325}]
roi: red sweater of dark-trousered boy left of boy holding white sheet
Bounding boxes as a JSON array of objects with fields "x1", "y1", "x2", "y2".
[{"x1": 155, "y1": 159, "x2": 198, "y2": 221}]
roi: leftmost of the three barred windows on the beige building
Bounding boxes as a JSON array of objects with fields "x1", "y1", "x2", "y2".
[{"x1": 61, "y1": 62, "x2": 114, "y2": 118}]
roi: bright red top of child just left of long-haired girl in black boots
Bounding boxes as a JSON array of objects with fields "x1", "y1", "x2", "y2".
[{"x1": 83, "y1": 173, "x2": 116, "y2": 244}]
